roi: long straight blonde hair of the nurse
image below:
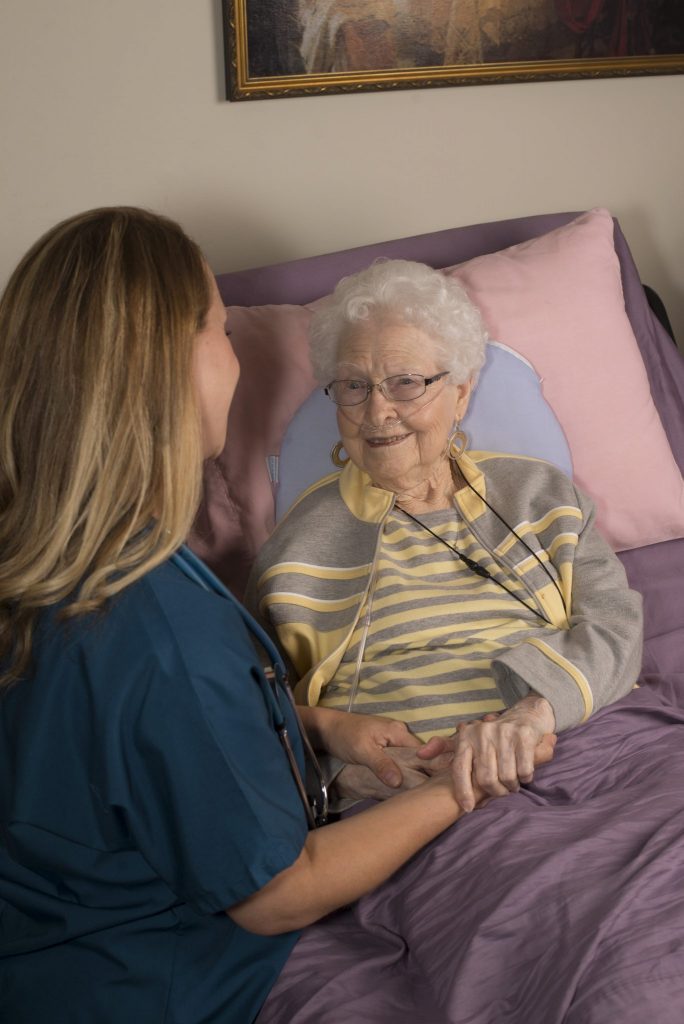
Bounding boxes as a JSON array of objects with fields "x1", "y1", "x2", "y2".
[{"x1": 0, "y1": 208, "x2": 210, "y2": 687}]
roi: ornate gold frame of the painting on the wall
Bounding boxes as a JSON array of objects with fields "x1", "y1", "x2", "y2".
[{"x1": 222, "y1": 0, "x2": 684, "y2": 100}]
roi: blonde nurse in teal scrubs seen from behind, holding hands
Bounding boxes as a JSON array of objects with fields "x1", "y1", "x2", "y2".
[{"x1": 0, "y1": 208, "x2": 475, "y2": 1024}]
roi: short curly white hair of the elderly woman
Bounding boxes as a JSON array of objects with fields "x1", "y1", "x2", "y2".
[{"x1": 309, "y1": 259, "x2": 488, "y2": 385}]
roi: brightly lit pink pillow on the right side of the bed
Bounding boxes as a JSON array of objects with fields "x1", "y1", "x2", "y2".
[{"x1": 444, "y1": 210, "x2": 684, "y2": 551}]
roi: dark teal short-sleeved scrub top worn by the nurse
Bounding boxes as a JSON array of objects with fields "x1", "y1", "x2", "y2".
[{"x1": 0, "y1": 561, "x2": 307, "y2": 1024}]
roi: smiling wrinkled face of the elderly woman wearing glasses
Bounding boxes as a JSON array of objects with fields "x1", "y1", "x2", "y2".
[{"x1": 336, "y1": 318, "x2": 470, "y2": 495}]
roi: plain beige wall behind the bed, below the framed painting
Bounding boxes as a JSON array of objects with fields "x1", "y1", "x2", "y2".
[{"x1": 0, "y1": 0, "x2": 684, "y2": 341}]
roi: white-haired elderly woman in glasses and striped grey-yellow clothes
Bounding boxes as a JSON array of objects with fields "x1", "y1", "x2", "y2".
[{"x1": 248, "y1": 261, "x2": 642, "y2": 810}]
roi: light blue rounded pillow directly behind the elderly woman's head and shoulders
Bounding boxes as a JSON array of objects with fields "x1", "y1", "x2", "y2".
[{"x1": 270, "y1": 341, "x2": 572, "y2": 520}]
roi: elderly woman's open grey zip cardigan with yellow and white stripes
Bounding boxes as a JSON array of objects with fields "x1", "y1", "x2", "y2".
[{"x1": 246, "y1": 452, "x2": 642, "y2": 731}]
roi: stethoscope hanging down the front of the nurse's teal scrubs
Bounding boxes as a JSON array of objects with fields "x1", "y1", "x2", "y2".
[{"x1": 171, "y1": 545, "x2": 328, "y2": 828}]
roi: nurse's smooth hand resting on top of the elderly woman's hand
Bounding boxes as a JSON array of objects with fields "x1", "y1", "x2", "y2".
[{"x1": 298, "y1": 708, "x2": 425, "y2": 791}]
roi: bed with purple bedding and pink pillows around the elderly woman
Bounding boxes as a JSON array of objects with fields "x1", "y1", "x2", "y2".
[{"x1": 193, "y1": 210, "x2": 684, "y2": 1024}]
